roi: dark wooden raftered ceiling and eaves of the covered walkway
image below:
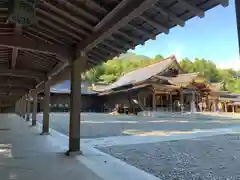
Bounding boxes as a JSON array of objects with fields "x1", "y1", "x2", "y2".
[{"x1": 0, "y1": 0, "x2": 231, "y2": 106}]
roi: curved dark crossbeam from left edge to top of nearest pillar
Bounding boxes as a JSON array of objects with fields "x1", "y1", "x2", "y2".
[{"x1": 0, "y1": 35, "x2": 71, "y2": 61}]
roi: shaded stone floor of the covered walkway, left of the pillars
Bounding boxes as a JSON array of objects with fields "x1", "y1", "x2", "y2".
[{"x1": 0, "y1": 114, "x2": 101, "y2": 180}]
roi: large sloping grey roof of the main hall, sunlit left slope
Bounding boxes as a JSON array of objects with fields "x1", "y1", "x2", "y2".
[{"x1": 101, "y1": 56, "x2": 176, "y2": 91}]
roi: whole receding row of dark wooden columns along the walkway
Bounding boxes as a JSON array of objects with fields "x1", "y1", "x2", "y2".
[{"x1": 16, "y1": 53, "x2": 86, "y2": 155}]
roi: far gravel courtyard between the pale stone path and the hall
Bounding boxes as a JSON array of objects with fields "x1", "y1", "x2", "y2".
[{"x1": 38, "y1": 113, "x2": 240, "y2": 138}]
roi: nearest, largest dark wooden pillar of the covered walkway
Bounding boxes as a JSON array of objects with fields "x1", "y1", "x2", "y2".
[{"x1": 66, "y1": 53, "x2": 87, "y2": 156}]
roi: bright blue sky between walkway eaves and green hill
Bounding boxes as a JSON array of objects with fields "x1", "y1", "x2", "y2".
[{"x1": 131, "y1": 0, "x2": 240, "y2": 69}]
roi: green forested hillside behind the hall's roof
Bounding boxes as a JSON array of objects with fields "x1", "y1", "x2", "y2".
[{"x1": 82, "y1": 53, "x2": 240, "y2": 93}]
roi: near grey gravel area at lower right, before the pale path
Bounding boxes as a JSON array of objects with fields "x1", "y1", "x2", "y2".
[{"x1": 99, "y1": 134, "x2": 240, "y2": 180}]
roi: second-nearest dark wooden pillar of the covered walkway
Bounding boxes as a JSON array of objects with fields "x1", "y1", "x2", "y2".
[{"x1": 41, "y1": 81, "x2": 50, "y2": 135}]
